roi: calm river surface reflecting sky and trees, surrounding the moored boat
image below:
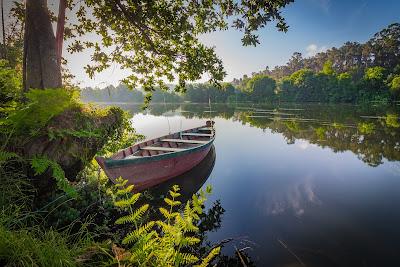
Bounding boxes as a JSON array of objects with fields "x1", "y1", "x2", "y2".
[{"x1": 112, "y1": 104, "x2": 400, "y2": 266}]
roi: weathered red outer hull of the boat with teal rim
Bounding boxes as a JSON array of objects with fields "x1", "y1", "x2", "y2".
[{"x1": 96, "y1": 142, "x2": 212, "y2": 191}]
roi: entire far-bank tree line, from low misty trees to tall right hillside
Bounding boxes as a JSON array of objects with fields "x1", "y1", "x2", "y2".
[{"x1": 82, "y1": 23, "x2": 400, "y2": 103}]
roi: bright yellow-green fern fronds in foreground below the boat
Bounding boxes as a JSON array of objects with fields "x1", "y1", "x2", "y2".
[{"x1": 112, "y1": 178, "x2": 220, "y2": 266}]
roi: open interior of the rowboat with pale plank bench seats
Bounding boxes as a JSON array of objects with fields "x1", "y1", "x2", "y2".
[{"x1": 112, "y1": 126, "x2": 214, "y2": 160}]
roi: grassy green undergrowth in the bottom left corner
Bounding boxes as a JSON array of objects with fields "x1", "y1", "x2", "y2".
[{"x1": 0, "y1": 152, "x2": 93, "y2": 267}]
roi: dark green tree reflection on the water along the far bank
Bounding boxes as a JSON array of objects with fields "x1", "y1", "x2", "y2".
[{"x1": 115, "y1": 104, "x2": 400, "y2": 166}]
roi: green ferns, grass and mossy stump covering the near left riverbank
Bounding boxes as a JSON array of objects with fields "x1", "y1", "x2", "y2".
[{"x1": 0, "y1": 62, "x2": 225, "y2": 266}]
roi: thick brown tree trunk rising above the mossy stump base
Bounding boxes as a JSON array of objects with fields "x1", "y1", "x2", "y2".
[{"x1": 23, "y1": 0, "x2": 62, "y2": 91}]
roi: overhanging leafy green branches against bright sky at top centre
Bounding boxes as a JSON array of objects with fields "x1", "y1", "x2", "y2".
[{"x1": 69, "y1": 0, "x2": 293, "y2": 98}]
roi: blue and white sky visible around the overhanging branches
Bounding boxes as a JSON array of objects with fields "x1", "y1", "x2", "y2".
[{"x1": 5, "y1": 0, "x2": 400, "y2": 87}]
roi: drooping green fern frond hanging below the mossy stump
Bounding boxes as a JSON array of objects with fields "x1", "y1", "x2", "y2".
[{"x1": 31, "y1": 157, "x2": 77, "y2": 197}]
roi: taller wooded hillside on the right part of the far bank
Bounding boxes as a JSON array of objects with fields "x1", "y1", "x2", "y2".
[{"x1": 232, "y1": 23, "x2": 400, "y2": 103}]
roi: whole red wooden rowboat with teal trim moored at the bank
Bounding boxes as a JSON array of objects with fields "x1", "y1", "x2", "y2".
[{"x1": 96, "y1": 121, "x2": 215, "y2": 191}]
